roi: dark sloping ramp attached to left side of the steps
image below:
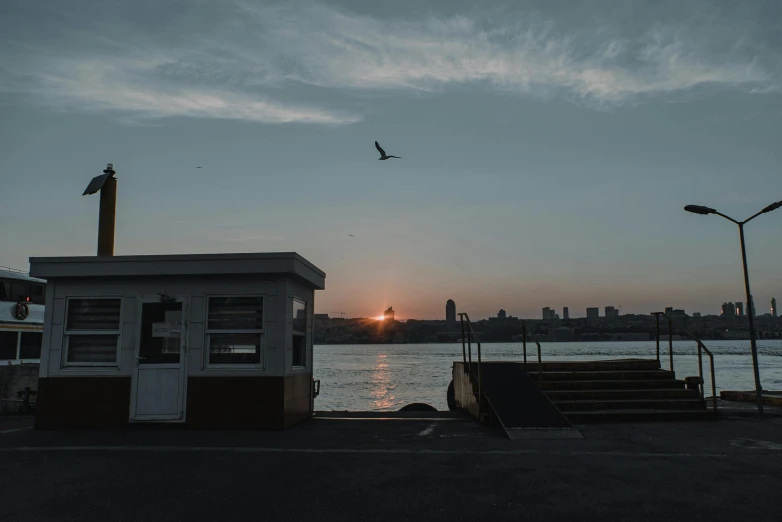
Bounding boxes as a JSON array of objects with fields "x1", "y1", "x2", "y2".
[{"x1": 476, "y1": 362, "x2": 581, "y2": 439}]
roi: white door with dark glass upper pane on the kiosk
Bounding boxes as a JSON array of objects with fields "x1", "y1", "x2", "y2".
[{"x1": 130, "y1": 298, "x2": 188, "y2": 421}]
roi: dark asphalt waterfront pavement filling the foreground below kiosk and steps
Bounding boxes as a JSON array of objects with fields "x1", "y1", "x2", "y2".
[{"x1": 0, "y1": 405, "x2": 782, "y2": 522}]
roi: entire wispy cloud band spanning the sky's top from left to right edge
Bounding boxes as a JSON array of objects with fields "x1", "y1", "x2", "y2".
[{"x1": 0, "y1": 0, "x2": 782, "y2": 120}]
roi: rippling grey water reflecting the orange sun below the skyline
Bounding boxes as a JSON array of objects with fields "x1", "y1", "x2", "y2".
[{"x1": 315, "y1": 339, "x2": 782, "y2": 411}]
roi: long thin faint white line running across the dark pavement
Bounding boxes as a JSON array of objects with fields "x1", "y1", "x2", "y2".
[{"x1": 0, "y1": 446, "x2": 775, "y2": 459}]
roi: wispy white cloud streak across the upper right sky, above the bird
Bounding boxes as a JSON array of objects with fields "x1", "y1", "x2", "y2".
[{"x1": 242, "y1": 4, "x2": 778, "y2": 104}]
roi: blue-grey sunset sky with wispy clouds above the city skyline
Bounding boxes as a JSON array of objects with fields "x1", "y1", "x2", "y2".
[{"x1": 0, "y1": 0, "x2": 782, "y2": 319}]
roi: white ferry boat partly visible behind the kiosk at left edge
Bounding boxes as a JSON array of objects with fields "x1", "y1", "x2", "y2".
[{"x1": 0, "y1": 266, "x2": 46, "y2": 365}]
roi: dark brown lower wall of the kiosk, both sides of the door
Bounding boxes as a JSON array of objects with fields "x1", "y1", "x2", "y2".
[{"x1": 35, "y1": 373, "x2": 312, "y2": 430}]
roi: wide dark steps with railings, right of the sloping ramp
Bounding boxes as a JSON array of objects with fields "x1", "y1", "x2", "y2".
[{"x1": 525, "y1": 359, "x2": 715, "y2": 424}]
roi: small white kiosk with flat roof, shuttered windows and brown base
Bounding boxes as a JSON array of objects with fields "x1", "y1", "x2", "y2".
[{"x1": 30, "y1": 253, "x2": 325, "y2": 429}]
